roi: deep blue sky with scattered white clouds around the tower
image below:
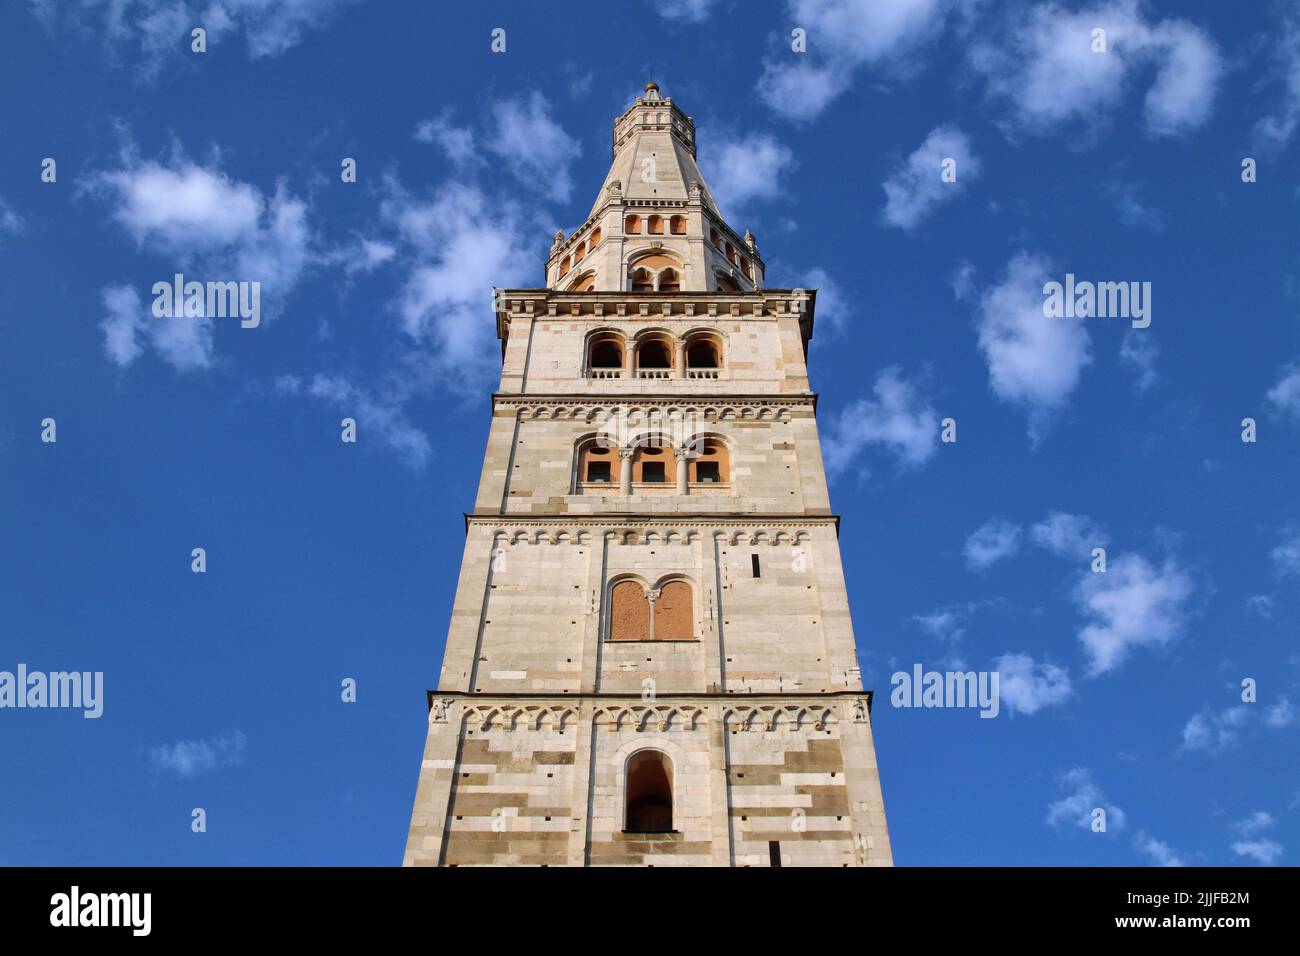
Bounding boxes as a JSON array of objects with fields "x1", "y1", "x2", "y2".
[{"x1": 0, "y1": 0, "x2": 1300, "y2": 865}]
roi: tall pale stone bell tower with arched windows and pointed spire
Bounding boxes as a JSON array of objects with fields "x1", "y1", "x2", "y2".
[{"x1": 403, "y1": 83, "x2": 892, "y2": 866}]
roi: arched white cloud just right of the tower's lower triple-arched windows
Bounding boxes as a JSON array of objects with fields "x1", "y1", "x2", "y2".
[{"x1": 824, "y1": 367, "x2": 939, "y2": 475}]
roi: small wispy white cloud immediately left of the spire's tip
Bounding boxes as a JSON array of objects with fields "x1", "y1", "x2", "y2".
[{"x1": 488, "y1": 90, "x2": 582, "y2": 203}]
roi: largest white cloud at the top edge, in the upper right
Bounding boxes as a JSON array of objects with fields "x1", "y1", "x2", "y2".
[{"x1": 970, "y1": 0, "x2": 1223, "y2": 137}]
